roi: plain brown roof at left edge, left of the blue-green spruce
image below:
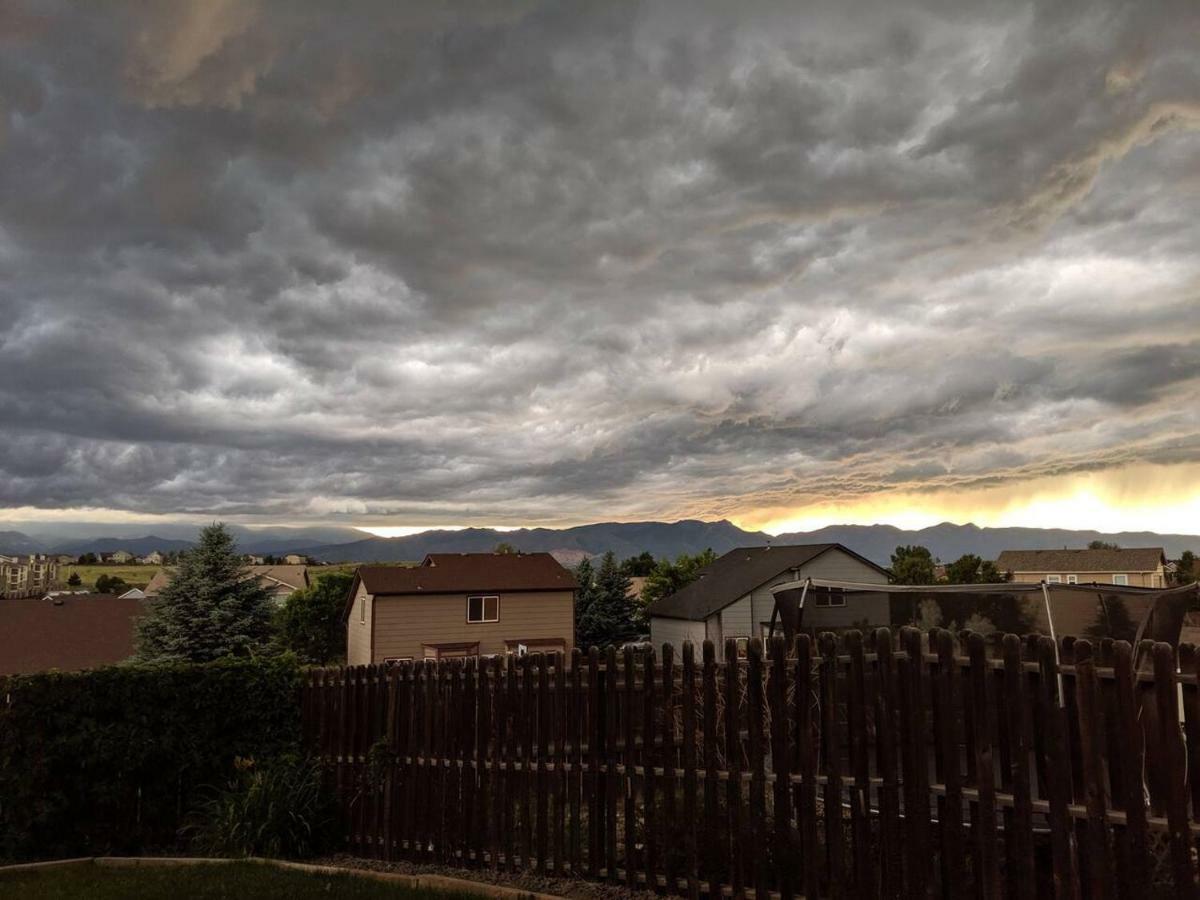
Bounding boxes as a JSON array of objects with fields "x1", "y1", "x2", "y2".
[{"x1": 0, "y1": 594, "x2": 145, "y2": 674}]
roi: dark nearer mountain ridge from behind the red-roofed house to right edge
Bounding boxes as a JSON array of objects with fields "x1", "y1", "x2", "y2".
[{"x1": 299, "y1": 520, "x2": 1200, "y2": 565}]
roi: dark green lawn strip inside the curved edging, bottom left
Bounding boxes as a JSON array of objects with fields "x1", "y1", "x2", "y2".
[{"x1": 0, "y1": 863, "x2": 487, "y2": 900}]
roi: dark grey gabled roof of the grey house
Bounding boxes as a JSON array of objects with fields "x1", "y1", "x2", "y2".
[{"x1": 649, "y1": 544, "x2": 887, "y2": 622}]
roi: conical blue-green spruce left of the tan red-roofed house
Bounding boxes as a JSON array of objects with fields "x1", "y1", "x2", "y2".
[{"x1": 138, "y1": 523, "x2": 271, "y2": 662}]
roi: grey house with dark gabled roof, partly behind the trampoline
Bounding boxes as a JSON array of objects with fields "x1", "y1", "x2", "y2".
[{"x1": 649, "y1": 544, "x2": 892, "y2": 658}]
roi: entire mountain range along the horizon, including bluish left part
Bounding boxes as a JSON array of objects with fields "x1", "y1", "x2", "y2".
[{"x1": 0, "y1": 520, "x2": 1200, "y2": 565}]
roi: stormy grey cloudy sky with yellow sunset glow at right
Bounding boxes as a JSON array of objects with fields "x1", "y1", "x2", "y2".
[{"x1": 0, "y1": 0, "x2": 1200, "y2": 533}]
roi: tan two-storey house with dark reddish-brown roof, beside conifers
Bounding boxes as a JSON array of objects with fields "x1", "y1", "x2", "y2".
[{"x1": 344, "y1": 553, "x2": 575, "y2": 666}]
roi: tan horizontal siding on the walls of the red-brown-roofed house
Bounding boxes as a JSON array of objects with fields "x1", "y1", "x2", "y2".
[{"x1": 369, "y1": 590, "x2": 575, "y2": 662}]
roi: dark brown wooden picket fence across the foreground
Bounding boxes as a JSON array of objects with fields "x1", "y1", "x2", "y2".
[{"x1": 304, "y1": 629, "x2": 1200, "y2": 900}]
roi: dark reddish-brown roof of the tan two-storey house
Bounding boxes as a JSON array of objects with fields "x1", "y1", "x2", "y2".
[{"x1": 346, "y1": 553, "x2": 575, "y2": 616}]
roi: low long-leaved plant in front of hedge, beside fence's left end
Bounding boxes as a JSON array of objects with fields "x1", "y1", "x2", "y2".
[{"x1": 184, "y1": 754, "x2": 335, "y2": 858}]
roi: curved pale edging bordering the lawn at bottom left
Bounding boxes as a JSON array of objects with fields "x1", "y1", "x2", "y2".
[{"x1": 0, "y1": 857, "x2": 563, "y2": 900}]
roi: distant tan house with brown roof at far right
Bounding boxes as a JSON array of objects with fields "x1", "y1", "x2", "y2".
[{"x1": 996, "y1": 547, "x2": 1169, "y2": 588}]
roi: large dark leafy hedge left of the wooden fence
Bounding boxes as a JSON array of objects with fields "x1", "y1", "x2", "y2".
[{"x1": 0, "y1": 658, "x2": 301, "y2": 859}]
